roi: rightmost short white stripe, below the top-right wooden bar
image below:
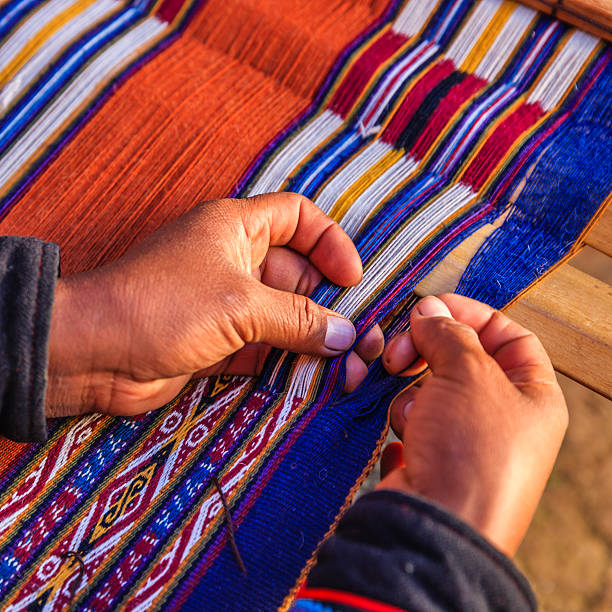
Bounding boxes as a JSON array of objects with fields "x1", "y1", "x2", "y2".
[{"x1": 527, "y1": 30, "x2": 599, "y2": 111}]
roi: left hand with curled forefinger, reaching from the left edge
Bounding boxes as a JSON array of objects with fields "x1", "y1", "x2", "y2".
[{"x1": 47, "y1": 193, "x2": 384, "y2": 416}]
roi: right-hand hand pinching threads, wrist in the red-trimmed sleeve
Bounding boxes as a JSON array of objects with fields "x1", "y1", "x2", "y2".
[{"x1": 379, "y1": 295, "x2": 568, "y2": 555}]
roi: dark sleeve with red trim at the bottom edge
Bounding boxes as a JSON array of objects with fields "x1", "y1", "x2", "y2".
[{"x1": 293, "y1": 490, "x2": 537, "y2": 612}]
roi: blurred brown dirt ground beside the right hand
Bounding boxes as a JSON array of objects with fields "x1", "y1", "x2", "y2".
[{"x1": 517, "y1": 248, "x2": 612, "y2": 612}]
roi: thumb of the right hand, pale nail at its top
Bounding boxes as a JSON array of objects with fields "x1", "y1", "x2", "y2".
[{"x1": 410, "y1": 296, "x2": 489, "y2": 380}]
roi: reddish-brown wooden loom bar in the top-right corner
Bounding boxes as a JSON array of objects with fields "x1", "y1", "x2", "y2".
[{"x1": 520, "y1": 0, "x2": 612, "y2": 41}]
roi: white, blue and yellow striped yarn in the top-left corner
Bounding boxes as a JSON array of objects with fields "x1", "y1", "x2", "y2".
[{"x1": 0, "y1": 0, "x2": 196, "y2": 215}]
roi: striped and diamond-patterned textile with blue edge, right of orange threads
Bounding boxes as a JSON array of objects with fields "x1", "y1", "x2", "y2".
[{"x1": 0, "y1": 0, "x2": 612, "y2": 610}]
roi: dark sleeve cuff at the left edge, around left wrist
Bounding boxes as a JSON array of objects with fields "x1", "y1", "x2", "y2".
[{"x1": 0, "y1": 236, "x2": 59, "y2": 442}]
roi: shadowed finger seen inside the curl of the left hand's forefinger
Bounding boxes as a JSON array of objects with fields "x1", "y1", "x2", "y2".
[{"x1": 259, "y1": 247, "x2": 323, "y2": 295}]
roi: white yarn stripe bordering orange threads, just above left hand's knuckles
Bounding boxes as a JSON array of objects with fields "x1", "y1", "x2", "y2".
[{"x1": 247, "y1": 110, "x2": 343, "y2": 196}]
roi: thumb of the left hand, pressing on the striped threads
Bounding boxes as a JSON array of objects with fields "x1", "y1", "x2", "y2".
[{"x1": 249, "y1": 283, "x2": 356, "y2": 357}]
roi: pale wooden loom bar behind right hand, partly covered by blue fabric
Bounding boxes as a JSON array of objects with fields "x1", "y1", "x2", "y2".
[{"x1": 415, "y1": 214, "x2": 612, "y2": 397}]
